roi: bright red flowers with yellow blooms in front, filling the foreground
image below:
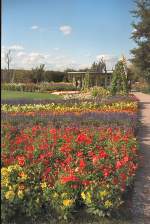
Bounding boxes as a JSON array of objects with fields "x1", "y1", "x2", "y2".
[{"x1": 1, "y1": 126, "x2": 137, "y2": 218}]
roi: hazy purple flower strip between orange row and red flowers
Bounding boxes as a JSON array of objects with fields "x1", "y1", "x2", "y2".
[{"x1": 1, "y1": 112, "x2": 137, "y2": 131}]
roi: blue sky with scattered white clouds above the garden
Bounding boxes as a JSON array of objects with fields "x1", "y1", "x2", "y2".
[{"x1": 2, "y1": 0, "x2": 137, "y2": 70}]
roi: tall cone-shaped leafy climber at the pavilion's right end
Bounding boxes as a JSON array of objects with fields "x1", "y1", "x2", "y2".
[{"x1": 110, "y1": 59, "x2": 128, "y2": 95}]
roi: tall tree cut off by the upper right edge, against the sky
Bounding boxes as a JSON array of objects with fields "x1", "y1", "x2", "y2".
[{"x1": 131, "y1": 0, "x2": 150, "y2": 85}]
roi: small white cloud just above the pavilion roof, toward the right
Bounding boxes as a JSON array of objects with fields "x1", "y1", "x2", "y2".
[{"x1": 96, "y1": 54, "x2": 118, "y2": 70}]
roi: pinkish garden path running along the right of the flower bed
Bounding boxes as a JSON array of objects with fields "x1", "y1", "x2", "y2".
[{"x1": 132, "y1": 92, "x2": 150, "y2": 224}]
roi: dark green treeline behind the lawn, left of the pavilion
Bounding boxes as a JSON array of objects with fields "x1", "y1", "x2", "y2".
[{"x1": 1, "y1": 69, "x2": 68, "y2": 83}]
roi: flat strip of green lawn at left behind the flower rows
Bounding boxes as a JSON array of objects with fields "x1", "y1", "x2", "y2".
[{"x1": 1, "y1": 90, "x2": 62, "y2": 100}]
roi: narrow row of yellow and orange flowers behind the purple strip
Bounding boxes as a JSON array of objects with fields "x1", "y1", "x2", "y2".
[{"x1": 1, "y1": 102, "x2": 138, "y2": 114}]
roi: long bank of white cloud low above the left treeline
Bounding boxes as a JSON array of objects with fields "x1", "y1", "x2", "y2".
[{"x1": 1, "y1": 46, "x2": 89, "y2": 71}]
